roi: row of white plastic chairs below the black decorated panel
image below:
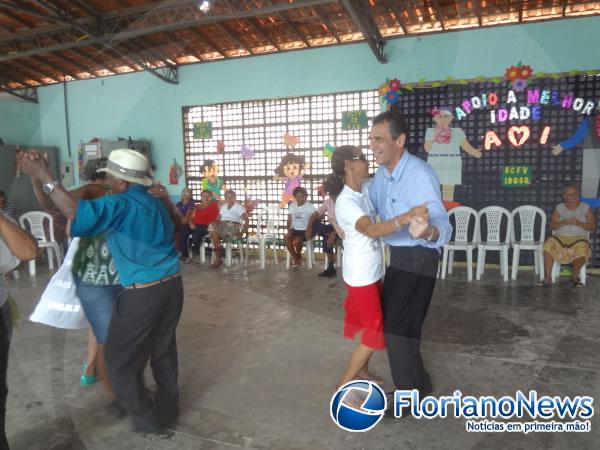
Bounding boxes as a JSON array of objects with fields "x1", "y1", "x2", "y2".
[{"x1": 441, "y1": 205, "x2": 586, "y2": 284}]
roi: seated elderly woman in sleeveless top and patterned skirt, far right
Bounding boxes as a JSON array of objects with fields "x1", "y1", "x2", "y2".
[{"x1": 541, "y1": 184, "x2": 596, "y2": 286}]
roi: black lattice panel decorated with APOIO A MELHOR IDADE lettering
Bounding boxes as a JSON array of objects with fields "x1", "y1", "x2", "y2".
[{"x1": 386, "y1": 66, "x2": 600, "y2": 208}]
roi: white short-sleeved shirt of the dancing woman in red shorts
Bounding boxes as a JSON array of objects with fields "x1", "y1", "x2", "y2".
[{"x1": 335, "y1": 186, "x2": 384, "y2": 286}]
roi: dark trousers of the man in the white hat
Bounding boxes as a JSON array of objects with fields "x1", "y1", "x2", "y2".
[{"x1": 106, "y1": 276, "x2": 183, "y2": 430}]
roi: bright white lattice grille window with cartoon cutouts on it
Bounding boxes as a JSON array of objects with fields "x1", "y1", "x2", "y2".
[{"x1": 182, "y1": 91, "x2": 380, "y2": 236}]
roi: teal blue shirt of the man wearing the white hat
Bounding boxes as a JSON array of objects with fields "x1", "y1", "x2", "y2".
[{"x1": 71, "y1": 184, "x2": 180, "y2": 286}]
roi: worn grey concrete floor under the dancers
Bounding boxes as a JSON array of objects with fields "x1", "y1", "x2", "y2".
[{"x1": 7, "y1": 256, "x2": 600, "y2": 450}]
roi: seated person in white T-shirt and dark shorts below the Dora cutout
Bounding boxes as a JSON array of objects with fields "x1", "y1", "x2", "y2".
[{"x1": 284, "y1": 186, "x2": 316, "y2": 268}]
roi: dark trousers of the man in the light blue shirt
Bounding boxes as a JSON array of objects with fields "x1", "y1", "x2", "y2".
[{"x1": 382, "y1": 246, "x2": 439, "y2": 391}]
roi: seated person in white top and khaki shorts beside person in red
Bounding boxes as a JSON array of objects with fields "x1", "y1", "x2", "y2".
[{"x1": 210, "y1": 191, "x2": 248, "y2": 267}]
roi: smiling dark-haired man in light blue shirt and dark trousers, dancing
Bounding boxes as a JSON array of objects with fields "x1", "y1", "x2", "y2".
[{"x1": 369, "y1": 111, "x2": 452, "y2": 406}]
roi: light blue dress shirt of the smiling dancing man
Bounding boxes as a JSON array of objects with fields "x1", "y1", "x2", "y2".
[{"x1": 368, "y1": 149, "x2": 452, "y2": 250}]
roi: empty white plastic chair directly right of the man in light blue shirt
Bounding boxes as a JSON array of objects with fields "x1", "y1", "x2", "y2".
[{"x1": 441, "y1": 206, "x2": 479, "y2": 281}]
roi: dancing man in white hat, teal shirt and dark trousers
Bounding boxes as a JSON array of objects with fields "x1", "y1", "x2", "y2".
[{"x1": 18, "y1": 149, "x2": 183, "y2": 432}]
